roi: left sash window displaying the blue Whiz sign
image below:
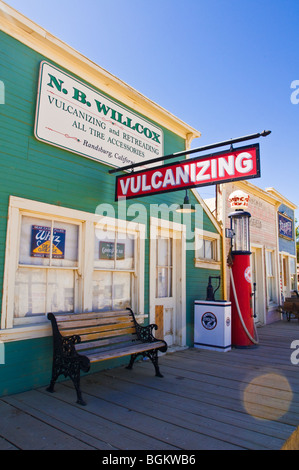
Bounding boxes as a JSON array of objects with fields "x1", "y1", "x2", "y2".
[{"x1": 14, "y1": 213, "x2": 80, "y2": 325}]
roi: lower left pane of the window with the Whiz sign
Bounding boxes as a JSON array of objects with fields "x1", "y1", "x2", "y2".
[{"x1": 14, "y1": 268, "x2": 47, "y2": 318}]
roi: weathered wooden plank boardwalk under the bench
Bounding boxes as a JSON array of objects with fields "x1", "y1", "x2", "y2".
[{"x1": 0, "y1": 320, "x2": 299, "y2": 451}]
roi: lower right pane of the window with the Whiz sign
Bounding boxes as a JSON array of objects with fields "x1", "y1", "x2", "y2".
[{"x1": 47, "y1": 269, "x2": 75, "y2": 313}]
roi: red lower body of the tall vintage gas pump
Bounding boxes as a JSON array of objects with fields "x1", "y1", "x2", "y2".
[{"x1": 230, "y1": 253, "x2": 254, "y2": 348}]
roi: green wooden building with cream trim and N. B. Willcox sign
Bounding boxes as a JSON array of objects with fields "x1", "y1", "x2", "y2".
[{"x1": 0, "y1": 1, "x2": 223, "y2": 396}]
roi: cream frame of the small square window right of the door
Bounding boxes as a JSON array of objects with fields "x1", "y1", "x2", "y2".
[{"x1": 194, "y1": 227, "x2": 221, "y2": 270}]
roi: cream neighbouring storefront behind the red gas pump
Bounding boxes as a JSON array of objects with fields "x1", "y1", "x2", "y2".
[{"x1": 210, "y1": 181, "x2": 296, "y2": 325}]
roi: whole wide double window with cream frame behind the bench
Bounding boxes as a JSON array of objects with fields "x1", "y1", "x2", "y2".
[{"x1": 1, "y1": 196, "x2": 145, "y2": 341}]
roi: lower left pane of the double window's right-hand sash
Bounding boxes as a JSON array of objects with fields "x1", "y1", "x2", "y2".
[{"x1": 92, "y1": 271, "x2": 112, "y2": 312}]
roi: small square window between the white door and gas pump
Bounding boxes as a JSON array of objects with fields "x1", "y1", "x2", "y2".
[{"x1": 195, "y1": 228, "x2": 221, "y2": 269}]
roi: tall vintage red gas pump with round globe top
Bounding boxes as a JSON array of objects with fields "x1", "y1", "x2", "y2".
[{"x1": 228, "y1": 191, "x2": 258, "y2": 348}]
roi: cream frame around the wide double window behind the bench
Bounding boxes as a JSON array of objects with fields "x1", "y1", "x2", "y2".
[{"x1": 0, "y1": 196, "x2": 145, "y2": 341}]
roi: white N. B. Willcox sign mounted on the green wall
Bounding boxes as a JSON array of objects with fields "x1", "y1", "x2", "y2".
[{"x1": 34, "y1": 61, "x2": 163, "y2": 167}]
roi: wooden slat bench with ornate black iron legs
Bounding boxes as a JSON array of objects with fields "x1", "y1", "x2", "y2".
[{"x1": 47, "y1": 309, "x2": 167, "y2": 405}]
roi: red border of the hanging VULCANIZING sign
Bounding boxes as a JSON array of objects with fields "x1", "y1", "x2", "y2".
[{"x1": 115, "y1": 143, "x2": 261, "y2": 202}]
